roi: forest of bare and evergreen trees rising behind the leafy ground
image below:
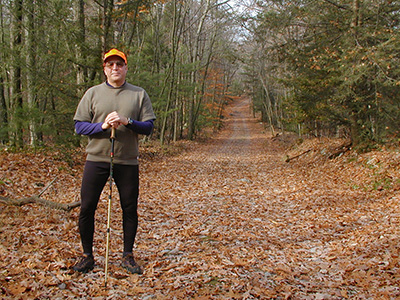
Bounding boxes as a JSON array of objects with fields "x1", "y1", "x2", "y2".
[{"x1": 0, "y1": 0, "x2": 400, "y2": 150}]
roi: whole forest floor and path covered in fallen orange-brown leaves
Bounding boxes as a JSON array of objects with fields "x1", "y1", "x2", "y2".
[{"x1": 0, "y1": 99, "x2": 400, "y2": 299}]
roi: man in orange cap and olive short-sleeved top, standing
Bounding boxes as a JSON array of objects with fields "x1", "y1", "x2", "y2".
[{"x1": 73, "y1": 49, "x2": 156, "y2": 274}]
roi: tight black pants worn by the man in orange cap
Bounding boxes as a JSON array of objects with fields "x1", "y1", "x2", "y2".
[{"x1": 79, "y1": 161, "x2": 139, "y2": 254}]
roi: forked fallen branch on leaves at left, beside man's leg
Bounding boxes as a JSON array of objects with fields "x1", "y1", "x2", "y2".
[{"x1": 0, "y1": 177, "x2": 81, "y2": 211}]
